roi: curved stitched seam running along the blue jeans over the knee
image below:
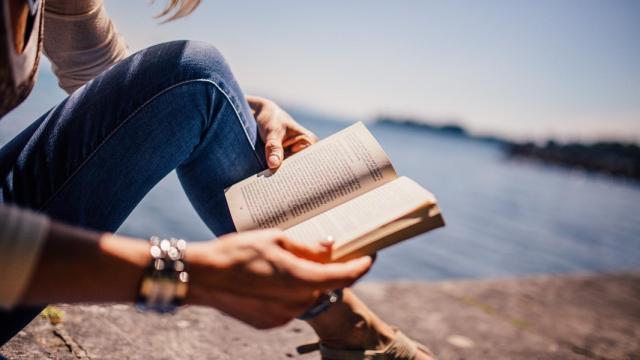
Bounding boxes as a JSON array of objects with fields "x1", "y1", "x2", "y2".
[{"x1": 38, "y1": 79, "x2": 259, "y2": 212}]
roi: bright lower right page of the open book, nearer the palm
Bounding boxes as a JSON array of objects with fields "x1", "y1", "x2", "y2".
[{"x1": 285, "y1": 177, "x2": 436, "y2": 249}]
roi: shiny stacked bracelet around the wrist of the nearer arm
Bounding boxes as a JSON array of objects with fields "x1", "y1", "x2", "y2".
[{"x1": 136, "y1": 236, "x2": 189, "y2": 313}]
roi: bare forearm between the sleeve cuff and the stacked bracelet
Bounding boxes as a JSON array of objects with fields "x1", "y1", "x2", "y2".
[{"x1": 21, "y1": 222, "x2": 150, "y2": 304}]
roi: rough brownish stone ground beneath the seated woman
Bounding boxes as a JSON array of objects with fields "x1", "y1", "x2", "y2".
[{"x1": 0, "y1": 272, "x2": 640, "y2": 360}]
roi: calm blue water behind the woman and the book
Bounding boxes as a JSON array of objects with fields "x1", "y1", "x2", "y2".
[{"x1": 0, "y1": 68, "x2": 640, "y2": 280}]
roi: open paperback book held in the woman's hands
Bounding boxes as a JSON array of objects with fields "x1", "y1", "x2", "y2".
[{"x1": 225, "y1": 122, "x2": 444, "y2": 261}]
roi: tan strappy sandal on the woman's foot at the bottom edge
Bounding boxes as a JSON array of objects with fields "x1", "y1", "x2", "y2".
[{"x1": 297, "y1": 329, "x2": 435, "y2": 360}]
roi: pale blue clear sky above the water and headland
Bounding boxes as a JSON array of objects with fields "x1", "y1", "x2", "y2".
[{"x1": 30, "y1": 0, "x2": 640, "y2": 141}]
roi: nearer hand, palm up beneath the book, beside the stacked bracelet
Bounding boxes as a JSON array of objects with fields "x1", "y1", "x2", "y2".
[{"x1": 186, "y1": 229, "x2": 371, "y2": 329}]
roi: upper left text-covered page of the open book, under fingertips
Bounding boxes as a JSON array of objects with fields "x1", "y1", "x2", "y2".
[{"x1": 225, "y1": 122, "x2": 397, "y2": 231}]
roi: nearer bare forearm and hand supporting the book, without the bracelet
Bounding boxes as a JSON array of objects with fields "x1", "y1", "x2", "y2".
[{"x1": 17, "y1": 219, "x2": 371, "y2": 328}]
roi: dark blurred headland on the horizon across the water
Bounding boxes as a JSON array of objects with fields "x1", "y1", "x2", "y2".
[{"x1": 376, "y1": 116, "x2": 640, "y2": 181}]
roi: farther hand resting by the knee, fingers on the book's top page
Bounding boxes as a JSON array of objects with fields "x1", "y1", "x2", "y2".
[{"x1": 247, "y1": 96, "x2": 318, "y2": 169}]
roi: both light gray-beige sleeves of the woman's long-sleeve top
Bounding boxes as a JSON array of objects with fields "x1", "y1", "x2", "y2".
[{"x1": 0, "y1": 0, "x2": 127, "y2": 309}]
